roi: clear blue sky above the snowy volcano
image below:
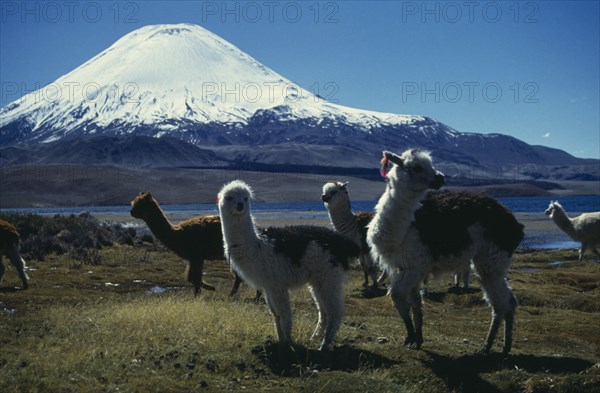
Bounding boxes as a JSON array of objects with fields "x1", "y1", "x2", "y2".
[{"x1": 0, "y1": 0, "x2": 600, "y2": 158}]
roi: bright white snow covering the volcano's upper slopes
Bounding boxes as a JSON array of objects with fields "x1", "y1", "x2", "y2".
[{"x1": 0, "y1": 24, "x2": 423, "y2": 142}]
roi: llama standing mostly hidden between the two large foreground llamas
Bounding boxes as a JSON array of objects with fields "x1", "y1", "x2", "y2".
[{"x1": 321, "y1": 181, "x2": 377, "y2": 288}]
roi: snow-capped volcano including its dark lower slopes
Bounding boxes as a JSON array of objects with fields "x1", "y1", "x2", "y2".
[{"x1": 0, "y1": 24, "x2": 592, "y2": 172}]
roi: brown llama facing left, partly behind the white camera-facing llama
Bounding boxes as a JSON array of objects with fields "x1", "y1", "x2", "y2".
[{"x1": 130, "y1": 192, "x2": 260, "y2": 298}]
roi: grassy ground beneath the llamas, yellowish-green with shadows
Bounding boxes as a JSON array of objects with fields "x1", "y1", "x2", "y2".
[{"x1": 0, "y1": 245, "x2": 600, "y2": 393}]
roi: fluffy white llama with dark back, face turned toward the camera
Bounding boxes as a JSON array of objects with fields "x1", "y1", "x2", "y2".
[{"x1": 218, "y1": 180, "x2": 359, "y2": 350}]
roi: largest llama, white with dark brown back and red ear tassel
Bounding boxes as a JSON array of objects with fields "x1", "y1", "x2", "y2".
[{"x1": 367, "y1": 149, "x2": 523, "y2": 353}]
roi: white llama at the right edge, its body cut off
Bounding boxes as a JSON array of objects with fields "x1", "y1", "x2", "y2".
[{"x1": 545, "y1": 201, "x2": 600, "y2": 261}]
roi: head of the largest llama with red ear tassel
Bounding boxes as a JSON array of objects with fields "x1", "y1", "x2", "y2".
[{"x1": 381, "y1": 149, "x2": 444, "y2": 191}]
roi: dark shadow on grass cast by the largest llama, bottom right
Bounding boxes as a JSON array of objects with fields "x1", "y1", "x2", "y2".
[{"x1": 423, "y1": 351, "x2": 593, "y2": 393}]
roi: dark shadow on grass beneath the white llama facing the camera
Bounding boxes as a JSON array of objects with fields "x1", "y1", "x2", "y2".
[{"x1": 252, "y1": 341, "x2": 400, "y2": 377}]
